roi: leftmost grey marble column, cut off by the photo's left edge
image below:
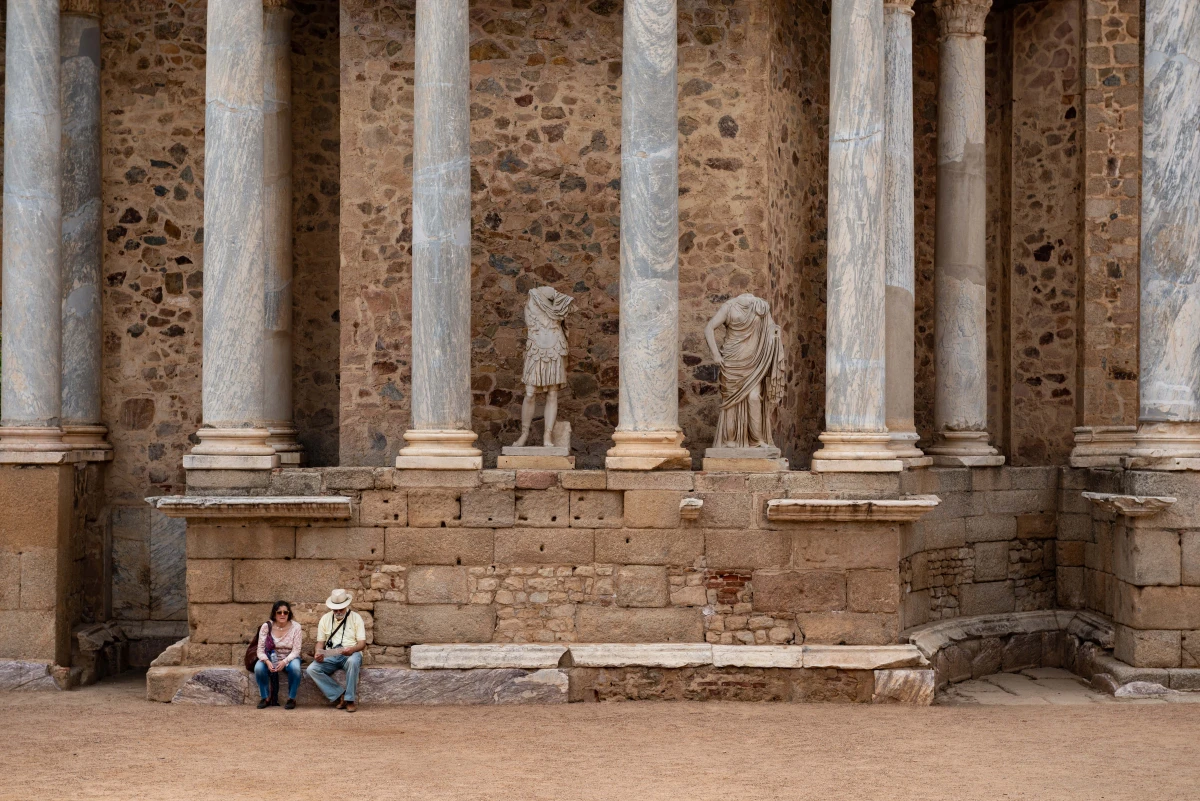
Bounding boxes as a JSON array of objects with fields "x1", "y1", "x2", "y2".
[{"x1": 0, "y1": 0, "x2": 68, "y2": 462}]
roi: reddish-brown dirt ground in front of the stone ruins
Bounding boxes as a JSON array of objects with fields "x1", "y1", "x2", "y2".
[{"x1": 0, "y1": 675, "x2": 1200, "y2": 801}]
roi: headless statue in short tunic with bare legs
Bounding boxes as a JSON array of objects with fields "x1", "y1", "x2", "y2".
[{"x1": 512, "y1": 287, "x2": 575, "y2": 447}]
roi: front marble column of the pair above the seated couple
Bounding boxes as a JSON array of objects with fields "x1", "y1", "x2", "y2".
[{"x1": 184, "y1": 0, "x2": 280, "y2": 470}]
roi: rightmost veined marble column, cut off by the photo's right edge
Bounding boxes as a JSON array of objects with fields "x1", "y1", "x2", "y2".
[{"x1": 1128, "y1": 0, "x2": 1200, "y2": 470}]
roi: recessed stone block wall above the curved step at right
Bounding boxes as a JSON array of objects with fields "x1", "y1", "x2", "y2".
[{"x1": 900, "y1": 468, "x2": 1058, "y2": 628}]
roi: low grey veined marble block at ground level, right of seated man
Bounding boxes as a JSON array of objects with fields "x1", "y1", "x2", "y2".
[{"x1": 359, "y1": 668, "x2": 568, "y2": 706}]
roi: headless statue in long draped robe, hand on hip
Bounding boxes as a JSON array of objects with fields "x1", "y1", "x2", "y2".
[{"x1": 704, "y1": 294, "x2": 787, "y2": 448}]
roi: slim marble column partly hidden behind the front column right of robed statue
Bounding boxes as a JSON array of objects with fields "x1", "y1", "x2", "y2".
[{"x1": 883, "y1": 0, "x2": 932, "y2": 468}]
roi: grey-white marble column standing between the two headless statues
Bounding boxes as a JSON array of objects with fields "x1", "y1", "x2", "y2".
[{"x1": 605, "y1": 0, "x2": 691, "y2": 470}]
